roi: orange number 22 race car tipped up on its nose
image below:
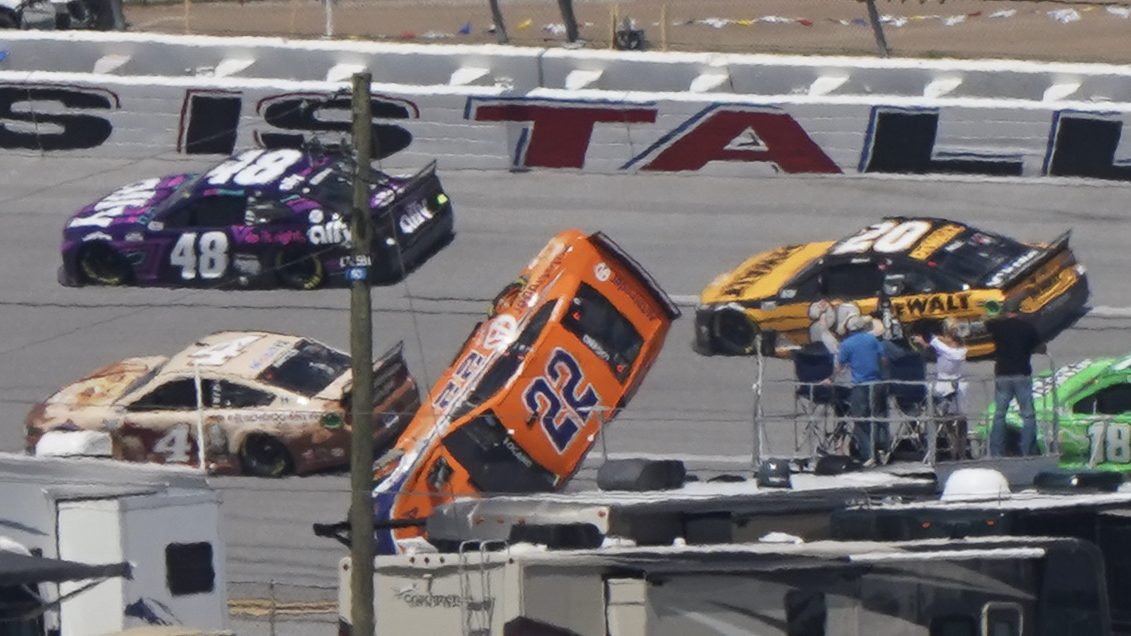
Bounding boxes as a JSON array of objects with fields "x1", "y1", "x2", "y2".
[{"x1": 373, "y1": 230, "x2": 680, "y2": 552}]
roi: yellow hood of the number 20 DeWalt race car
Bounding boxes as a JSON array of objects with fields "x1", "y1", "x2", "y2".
[{"x1": 700, "y1": 241, "x2": 832, "y2": 304}]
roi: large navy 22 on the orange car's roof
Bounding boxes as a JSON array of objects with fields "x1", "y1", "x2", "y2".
[{"x1": 523, "y1": 349, "x2": 601, "y2": 453}]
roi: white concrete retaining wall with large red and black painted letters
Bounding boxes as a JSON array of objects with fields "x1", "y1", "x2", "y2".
[{"x1": 0, "y1": 32, "x2": 1131, "y2": 181}]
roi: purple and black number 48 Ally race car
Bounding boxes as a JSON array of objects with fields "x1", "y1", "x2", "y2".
[{"x1": 59, "y1": 148, "x2": 452, "y2": 290}]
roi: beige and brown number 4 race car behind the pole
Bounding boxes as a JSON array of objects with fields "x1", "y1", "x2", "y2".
[{"x1": 25, "y1": 332, "x2": 420, "y2": 476}]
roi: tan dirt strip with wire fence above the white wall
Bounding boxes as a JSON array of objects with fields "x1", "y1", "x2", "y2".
[{"x1": 110, "y1": 0, "x2": 1131, "y2": 61}]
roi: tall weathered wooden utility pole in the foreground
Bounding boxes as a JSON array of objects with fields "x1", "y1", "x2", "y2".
[{"x1": 346, "y1": 72, "x2": 374, "y2": 636}]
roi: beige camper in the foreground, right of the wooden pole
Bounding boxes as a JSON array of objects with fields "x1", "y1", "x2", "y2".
[{"x1": 339, "y1": 538, "x2": 1111, "y2": 636}]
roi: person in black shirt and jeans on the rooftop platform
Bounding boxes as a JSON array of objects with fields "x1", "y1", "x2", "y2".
[{"x1": 985, "y1": 301, "x2": 1045, "y2": 457}]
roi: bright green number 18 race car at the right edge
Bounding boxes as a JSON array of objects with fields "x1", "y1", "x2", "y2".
[{"x1": 978, "y1": 354, "x2": 1131, "y2": 472}]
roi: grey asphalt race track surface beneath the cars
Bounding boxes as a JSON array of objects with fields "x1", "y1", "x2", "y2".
[{"x1": 0, "y1": 156, "x2": 1131, "y2": 634}]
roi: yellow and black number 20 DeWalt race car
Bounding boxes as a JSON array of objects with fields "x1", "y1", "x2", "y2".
[{"x1": 694, "y1": 217, "x2": 1088, "y2": 358}]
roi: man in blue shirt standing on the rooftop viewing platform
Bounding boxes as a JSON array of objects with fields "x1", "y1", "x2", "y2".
[{"x1": 832, "y1": 316, "x2": 890, "y2": 464}]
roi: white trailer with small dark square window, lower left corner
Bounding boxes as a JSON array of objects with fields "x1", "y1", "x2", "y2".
[{"x1": 0, "y1": 454, "x2": 227, "y2": 636}]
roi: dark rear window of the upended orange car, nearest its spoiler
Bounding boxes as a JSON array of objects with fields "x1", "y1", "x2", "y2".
[{"x1": 562, "y1": 283, "x2": 644, "y2": 383}]
